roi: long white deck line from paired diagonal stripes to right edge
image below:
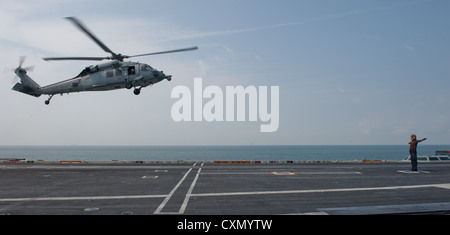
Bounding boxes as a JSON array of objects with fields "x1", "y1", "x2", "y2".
[{"x1": 191, "y1": 184, "x2": 450, "y2": 197}]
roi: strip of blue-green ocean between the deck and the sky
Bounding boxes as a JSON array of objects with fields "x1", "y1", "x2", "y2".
[{"x1": 0, "y1": 144, "x2": 450, "y2": 161}]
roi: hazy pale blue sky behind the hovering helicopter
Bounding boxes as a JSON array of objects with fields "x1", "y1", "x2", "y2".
[{"x1": 0, "y1": 0, "x2": 450, "y2": 145}]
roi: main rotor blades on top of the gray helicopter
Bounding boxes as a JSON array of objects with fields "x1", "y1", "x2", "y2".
[{"x1": 42, "y1": 17, "x2": 198, "y2": 61}]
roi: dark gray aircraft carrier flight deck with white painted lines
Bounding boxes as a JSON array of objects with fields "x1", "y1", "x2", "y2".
[{"x1": 0, "y1": 162, "x2": 450, "y2": 215}]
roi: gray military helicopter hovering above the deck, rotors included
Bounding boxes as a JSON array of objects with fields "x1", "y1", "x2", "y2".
[{"x1": 8, "y1": 17, "x2": 198, "y2": 105}]
